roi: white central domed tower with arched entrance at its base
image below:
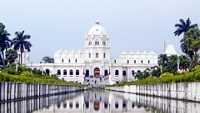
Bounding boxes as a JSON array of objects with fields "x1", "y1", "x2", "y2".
[{"x1": 85, "y1": 21, "x2": 110, "y2": 76}]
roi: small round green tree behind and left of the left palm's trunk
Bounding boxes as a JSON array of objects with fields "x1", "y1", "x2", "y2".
[{"x1": 6, "y1": 49, "x2": 17, "y2": 65}]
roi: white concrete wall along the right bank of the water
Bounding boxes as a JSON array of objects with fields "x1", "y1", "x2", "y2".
[{"x1": 106, "y1": 82, "x2": 200, "y2": 102}]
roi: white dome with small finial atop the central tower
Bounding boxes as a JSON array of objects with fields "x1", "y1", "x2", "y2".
[{"x1": 88, "y1": 21, "x2": 107, "y2": 35}]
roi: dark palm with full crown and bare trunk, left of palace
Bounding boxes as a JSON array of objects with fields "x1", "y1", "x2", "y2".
[{"x1": 12, "y1": 31, "x2": 32, "y2": 65}]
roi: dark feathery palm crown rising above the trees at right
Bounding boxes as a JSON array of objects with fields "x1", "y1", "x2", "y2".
[{"x1": 174, "y1": 18, "x2": 198, "y2": 36}]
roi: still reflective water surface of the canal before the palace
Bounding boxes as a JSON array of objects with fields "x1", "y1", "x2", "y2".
[{"x1": 0, "y1": 90, "x2": 200, "y2": 113}]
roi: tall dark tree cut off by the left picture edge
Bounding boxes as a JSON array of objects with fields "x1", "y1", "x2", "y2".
[{"x1": 0, "y1": 23, "x2": 11, "y2": 68}]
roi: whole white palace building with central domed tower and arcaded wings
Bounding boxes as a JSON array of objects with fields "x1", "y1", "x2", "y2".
[{"x1": 29, "y1": 21, "x2": 158, "y2": 84}]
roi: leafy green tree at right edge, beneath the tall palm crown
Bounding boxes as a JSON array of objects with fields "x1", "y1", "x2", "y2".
[{"x1": 181, "y1": 28, "x2": 200, "y2": 67}]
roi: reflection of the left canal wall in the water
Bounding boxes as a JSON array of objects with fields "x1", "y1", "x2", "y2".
[{"x1": 0, "y1": 92, "x2": 80, "y2": 113}]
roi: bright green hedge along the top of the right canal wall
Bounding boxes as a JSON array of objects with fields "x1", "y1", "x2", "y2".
[{"x1": 108, "y1": 65, "x2": 200, "y2": 87}]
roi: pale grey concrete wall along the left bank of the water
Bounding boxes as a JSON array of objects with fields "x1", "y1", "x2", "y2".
[{"x1": 0, "y1": 82, "x2": 84, "y2": 102}]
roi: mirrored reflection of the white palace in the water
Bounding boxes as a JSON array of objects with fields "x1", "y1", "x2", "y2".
[{"x1": 34, "y1": 91, "x2": 150, "y2": 113}]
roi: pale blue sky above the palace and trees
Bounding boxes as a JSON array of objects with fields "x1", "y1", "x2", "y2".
[{"x1": 0, "y1": 0, "x2": 200, "y2": 62}]
